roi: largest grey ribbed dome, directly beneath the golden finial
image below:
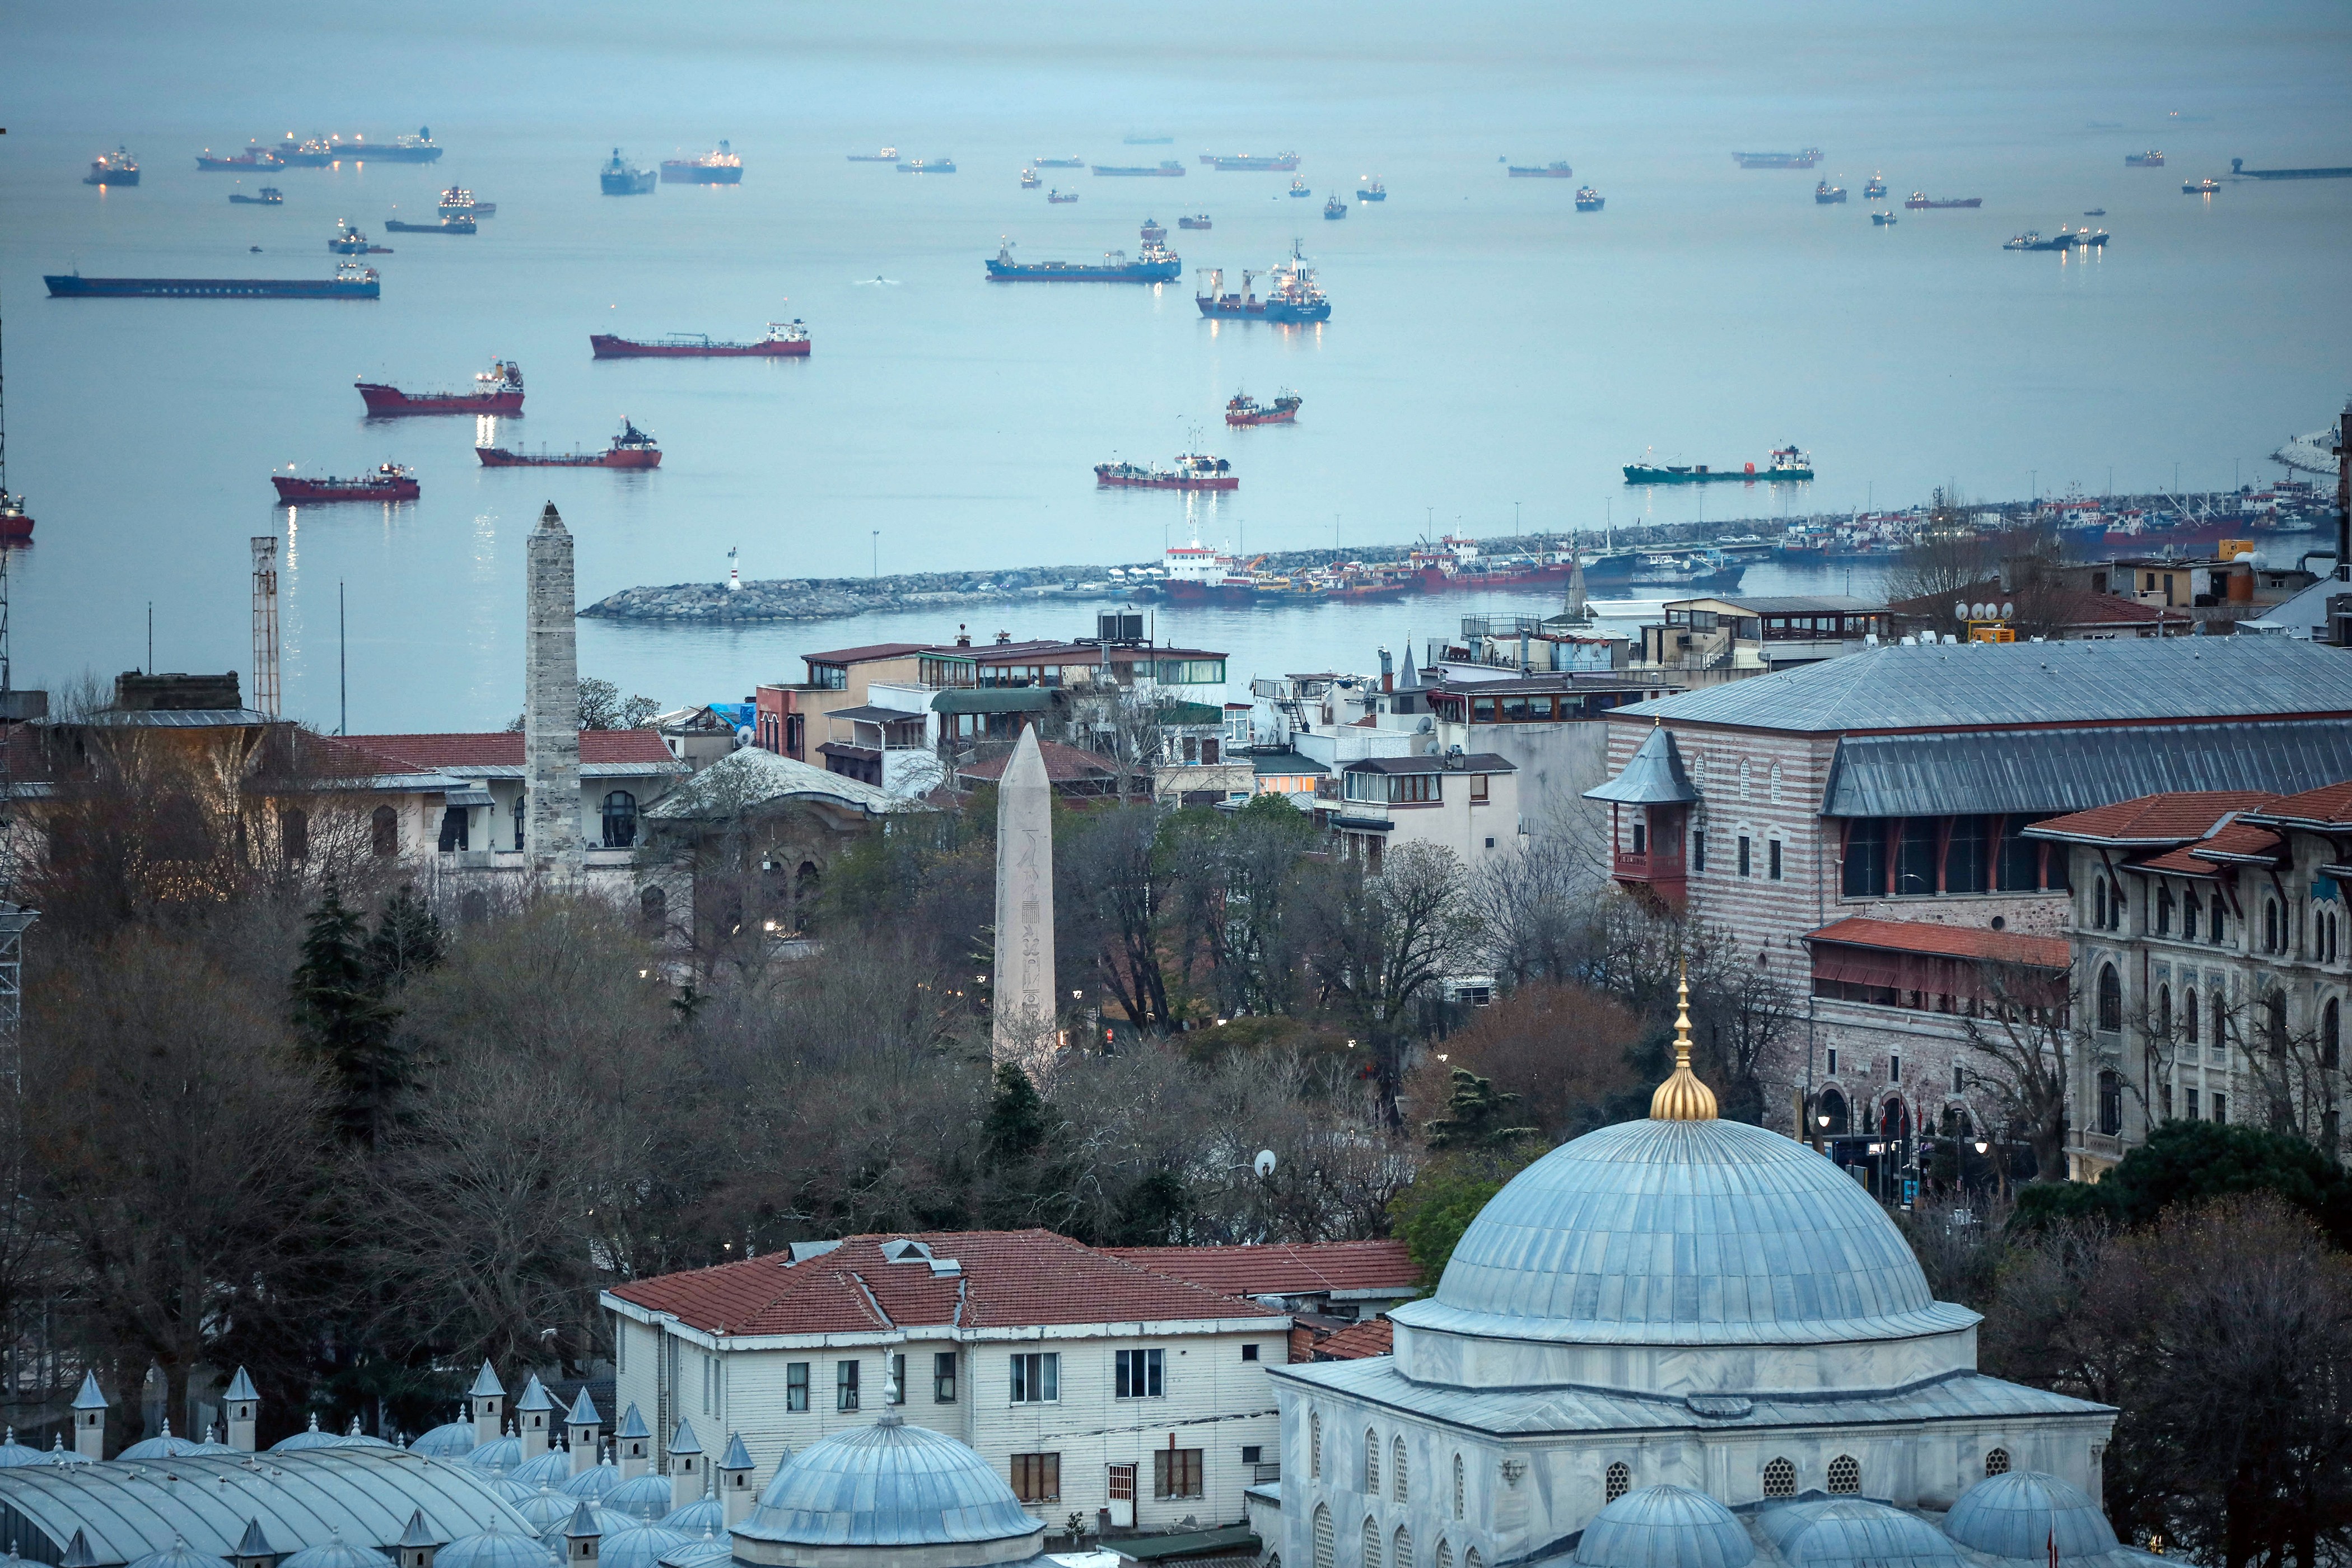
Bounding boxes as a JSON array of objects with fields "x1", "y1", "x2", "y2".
[{"x1": 1395, "y1": 1121, "x2": 1978, "y2": 1345}]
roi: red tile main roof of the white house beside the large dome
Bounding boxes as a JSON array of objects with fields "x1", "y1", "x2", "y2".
[{"x1": 597, "y1": 1230, "x2": 1270, "y2": 1333}]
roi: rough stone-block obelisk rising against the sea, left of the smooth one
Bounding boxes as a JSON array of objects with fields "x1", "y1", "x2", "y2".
[{"x1": 522, "y1": 501, "x2": 584, "y2": 881}]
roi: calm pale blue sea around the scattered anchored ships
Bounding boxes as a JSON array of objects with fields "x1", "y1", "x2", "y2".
[{"x1": 0, "y1": 2, "x2": 2352, "y2": 729}]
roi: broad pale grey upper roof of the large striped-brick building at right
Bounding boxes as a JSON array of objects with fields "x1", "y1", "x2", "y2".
[{"x1": 1613, "y1": 637, "x2": 2352, "y2": 734}]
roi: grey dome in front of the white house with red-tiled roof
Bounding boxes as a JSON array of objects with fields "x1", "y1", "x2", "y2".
[{"x1": 734, "y1": 1417, "x2": 1044, "y2": 1547}]
